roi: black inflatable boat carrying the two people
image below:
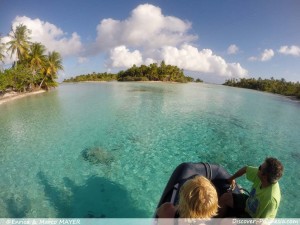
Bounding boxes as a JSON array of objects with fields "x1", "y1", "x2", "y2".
[{"x1": 155, "y1": 163, "x2": 243, "y2": 216}]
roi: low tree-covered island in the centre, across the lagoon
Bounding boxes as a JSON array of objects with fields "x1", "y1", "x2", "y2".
[{"x1": 64, "y1": 61, "x2": 203, "y2": 83}]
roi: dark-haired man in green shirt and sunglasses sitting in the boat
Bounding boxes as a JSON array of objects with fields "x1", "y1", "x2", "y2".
[{"x1": 218, "y1": 157, "x2": 283, "y2": 218}]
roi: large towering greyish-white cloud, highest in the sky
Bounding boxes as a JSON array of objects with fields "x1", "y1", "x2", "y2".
[{"x1": 96, "y1": 4, "x2": 197, "y2": 50}]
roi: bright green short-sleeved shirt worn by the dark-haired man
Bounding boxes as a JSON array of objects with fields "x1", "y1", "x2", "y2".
[{"x1": 245, "y1": 166, "x2": 281, "y2": 218}]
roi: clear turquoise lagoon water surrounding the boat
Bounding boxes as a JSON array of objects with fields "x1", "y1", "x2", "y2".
[{"x1": 0, "y1": 82, "x2": 300, "y2": 218}]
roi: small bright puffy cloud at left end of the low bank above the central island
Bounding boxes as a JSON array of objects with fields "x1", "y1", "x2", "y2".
[{"x1": 109, "y1": 45, "x2": 143, "y2": 68}]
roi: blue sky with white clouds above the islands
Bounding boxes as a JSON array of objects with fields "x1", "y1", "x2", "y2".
[{"x1": 0, "y1": 0, "x2": 300, "y2": 83}]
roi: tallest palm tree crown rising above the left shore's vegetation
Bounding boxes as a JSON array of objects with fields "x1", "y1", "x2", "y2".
[{"x1": 7, "y1": 24, "x2": 31, "y2": 62}]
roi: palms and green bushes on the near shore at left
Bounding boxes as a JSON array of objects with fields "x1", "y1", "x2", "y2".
[{"x1": 0, "y1": 24, "x2": 63, "y2": 95}]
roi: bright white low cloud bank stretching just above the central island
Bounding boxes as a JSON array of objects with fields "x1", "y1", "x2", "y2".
[{"x1": 109, "y1": 44, "x2": 248, "y2": 77}]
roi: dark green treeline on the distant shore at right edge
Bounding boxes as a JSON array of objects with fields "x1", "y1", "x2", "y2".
[{"x1": 223, "y1": 77, "x2": 300, "y2": 99}]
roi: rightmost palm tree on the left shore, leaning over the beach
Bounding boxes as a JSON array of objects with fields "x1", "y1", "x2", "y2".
[{"x1": 40, "y1": 51, "x2": 63, "y2": 88}]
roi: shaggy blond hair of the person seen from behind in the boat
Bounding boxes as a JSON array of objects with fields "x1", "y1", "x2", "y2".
[{"x1": 177, "y1": 176, "x2": 218, "y2": 218}]
